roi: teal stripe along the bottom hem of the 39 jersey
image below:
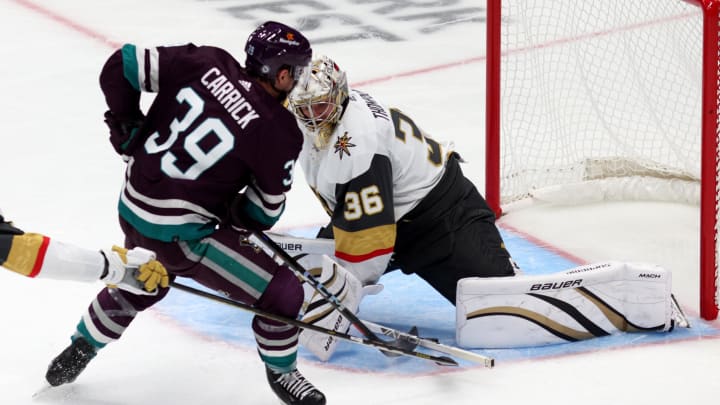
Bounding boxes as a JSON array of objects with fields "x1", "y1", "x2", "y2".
[{"x1": 118, "y1": 201, "x2": 215, "y2": 242}]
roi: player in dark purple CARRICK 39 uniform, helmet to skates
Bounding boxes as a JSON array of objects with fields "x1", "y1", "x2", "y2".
[{"x1": 46, "y1": 21, "x2": 325, "y2": 404}]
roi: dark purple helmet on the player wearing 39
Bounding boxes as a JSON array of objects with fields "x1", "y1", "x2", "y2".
[{"x1": 245, "y1": 21, "x2": 312, "y2": 82}]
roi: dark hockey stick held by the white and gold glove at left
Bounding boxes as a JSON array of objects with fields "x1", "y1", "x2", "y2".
[{"x1": 170, "y1": 281, "x2": 458, "y2": 366}]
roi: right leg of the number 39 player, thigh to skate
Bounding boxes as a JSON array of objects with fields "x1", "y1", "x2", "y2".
[{"x1": 181, "y1": 228, "x2": 325, "y2": 404}]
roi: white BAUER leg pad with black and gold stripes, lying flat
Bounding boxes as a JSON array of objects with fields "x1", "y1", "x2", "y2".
[{"x1": 456, "y1": 262, "x2": 672, "y2": 348}]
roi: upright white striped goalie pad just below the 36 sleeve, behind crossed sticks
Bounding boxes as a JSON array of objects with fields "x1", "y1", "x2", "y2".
[{"x1": 300, "y1": 255, "x2": 363, "y2": 361}]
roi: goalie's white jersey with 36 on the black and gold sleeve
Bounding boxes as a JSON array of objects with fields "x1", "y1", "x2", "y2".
[{"x1": 299, "y1": 90, "x2": 452, "y2": 284}]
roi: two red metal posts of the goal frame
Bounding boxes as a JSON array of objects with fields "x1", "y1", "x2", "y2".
[{"x1": 485, "y1": 0, "x2": 720, "y2": 320}]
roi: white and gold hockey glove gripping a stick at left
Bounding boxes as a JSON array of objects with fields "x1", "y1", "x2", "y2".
[{"x1": 100, "y1": 246, "x2": 170, "y2": 295}]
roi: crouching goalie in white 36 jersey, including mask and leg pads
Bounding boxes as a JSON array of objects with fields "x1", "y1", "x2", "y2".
[{"x1": 286, "y1": 56, "x2": 688, "y2": 360}]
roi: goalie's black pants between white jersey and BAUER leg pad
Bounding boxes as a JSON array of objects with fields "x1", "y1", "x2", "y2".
[{"x1": 389, "y1": 155, "x2": 515, "y2": 304}]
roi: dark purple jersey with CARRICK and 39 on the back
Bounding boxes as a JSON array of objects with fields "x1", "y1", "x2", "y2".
[{"x1": 100, "y1": 44, "x2": 302, "y2": 241}]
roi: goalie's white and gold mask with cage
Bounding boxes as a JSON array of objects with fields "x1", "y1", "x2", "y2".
[{"x1": 289, "y1": 56, "x2": 349, "y2": 149}]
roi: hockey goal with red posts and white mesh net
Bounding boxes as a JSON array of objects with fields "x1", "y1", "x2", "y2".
[{"x1": 486, "y1": 0, "x2": 720, "y2": 319}]
